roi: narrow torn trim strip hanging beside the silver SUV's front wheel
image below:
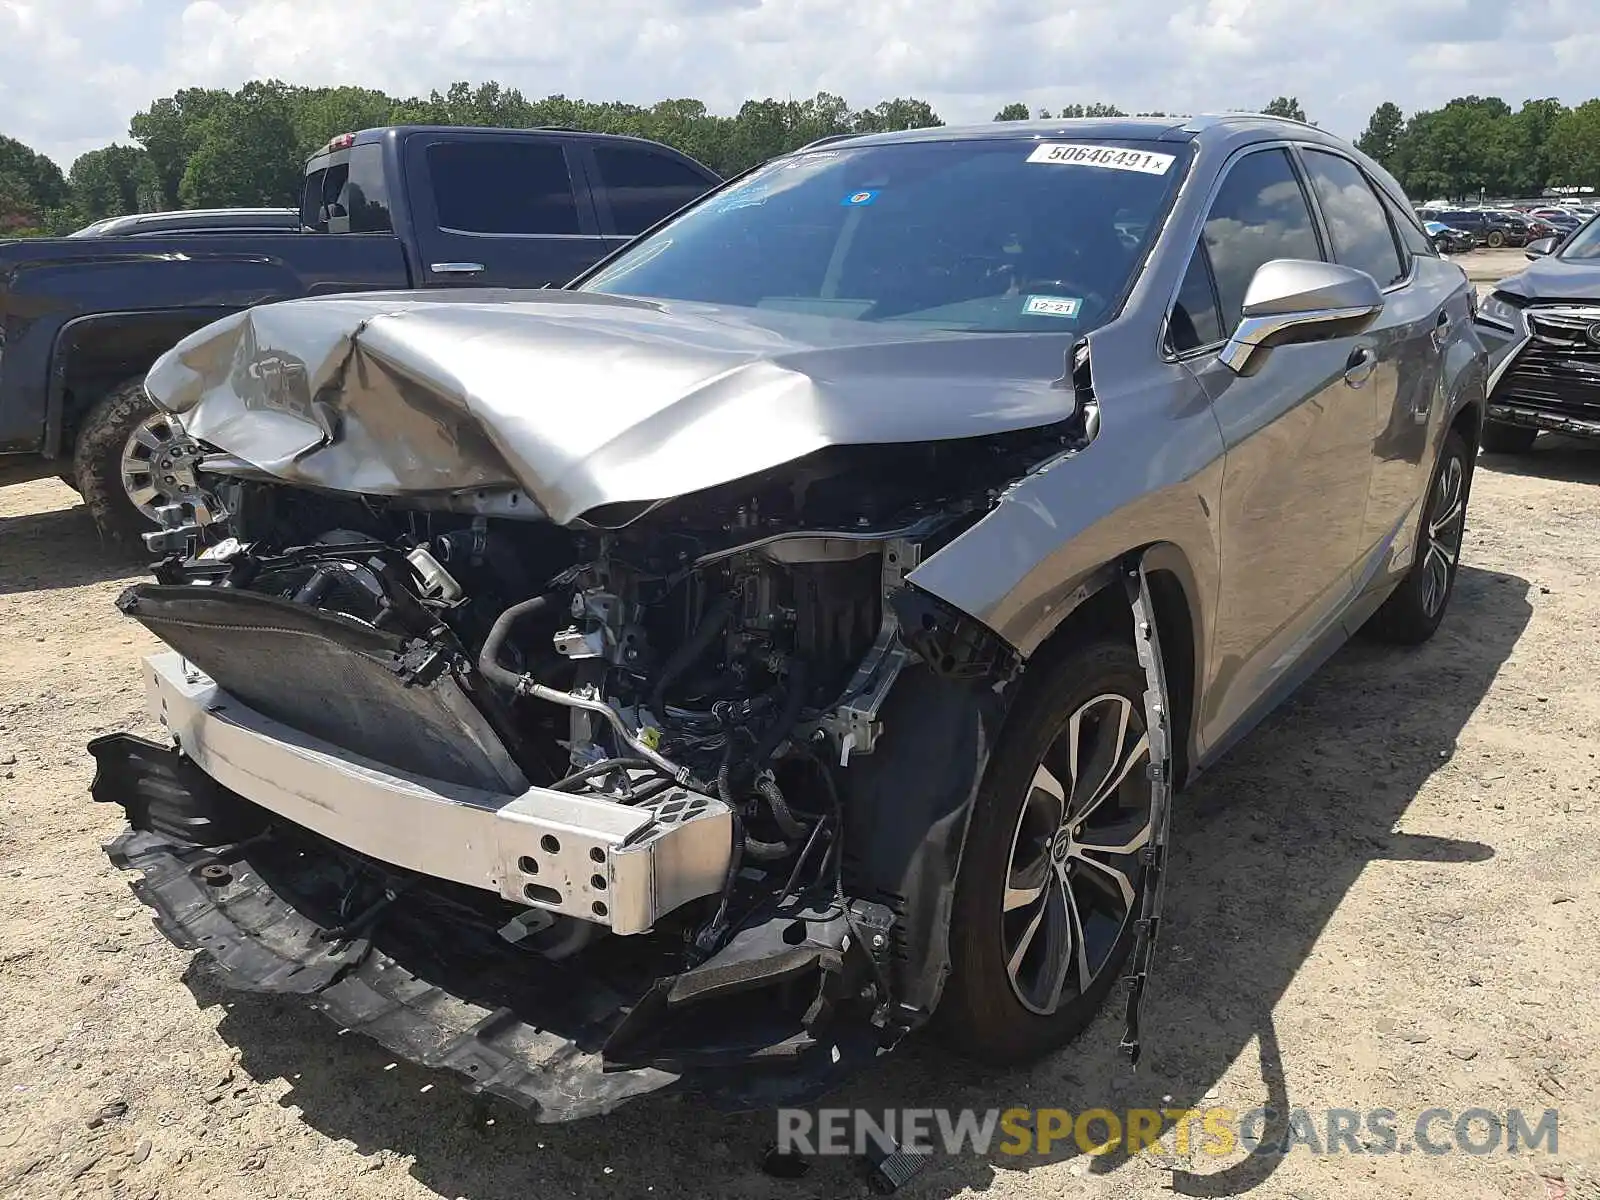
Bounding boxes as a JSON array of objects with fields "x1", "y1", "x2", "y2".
[{"x1": 1122, "y1": 562, "x2": 1173, "y2": 1066}]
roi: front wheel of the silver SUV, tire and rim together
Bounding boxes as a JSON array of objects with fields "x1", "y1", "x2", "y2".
[{"x1": 938, "y1": 642, "x2": 1152, "y2": 1064}]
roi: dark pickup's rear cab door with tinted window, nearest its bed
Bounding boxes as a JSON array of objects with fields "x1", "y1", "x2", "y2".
[{"x1": 405, "y1": 131, "x2": 606, "y2": 288}]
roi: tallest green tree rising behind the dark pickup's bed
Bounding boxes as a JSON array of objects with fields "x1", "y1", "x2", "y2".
[{"x1": 179, "y1": 80, "x2": 306, "y2": 208}]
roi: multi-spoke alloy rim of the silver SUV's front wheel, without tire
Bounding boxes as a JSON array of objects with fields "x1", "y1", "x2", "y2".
[{"x1": 1000, "y1": 693, "x2": 1150, "y2": 1016}]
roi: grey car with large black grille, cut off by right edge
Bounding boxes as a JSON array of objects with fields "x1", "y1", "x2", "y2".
[{"x1": 1477, "y1": 218, "x2": 1600, "y2": 453}]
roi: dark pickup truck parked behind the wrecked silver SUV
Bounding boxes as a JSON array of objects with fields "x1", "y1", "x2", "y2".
[{"x1": 0, "y1": 126, "x2": 720, "y2": 546}]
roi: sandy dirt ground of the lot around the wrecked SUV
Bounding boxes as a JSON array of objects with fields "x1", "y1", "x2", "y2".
[{"x1": 0, "y1": 401, "x2": 1600, "y2": 1200}]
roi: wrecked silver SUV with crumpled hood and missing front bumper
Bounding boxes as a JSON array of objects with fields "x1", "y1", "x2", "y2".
[{"x1": 91, "y1": 117, "x2": 1485, "y2": 1120}]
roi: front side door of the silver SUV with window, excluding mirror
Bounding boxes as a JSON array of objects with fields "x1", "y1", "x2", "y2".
[{"x1": 1170, "y1": 146, "x2": 1371, "y2": 744}]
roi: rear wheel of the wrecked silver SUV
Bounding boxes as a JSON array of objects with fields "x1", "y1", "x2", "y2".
[{"x1": 1366, "y1": 430, "x2": 1472, "y2": 646}]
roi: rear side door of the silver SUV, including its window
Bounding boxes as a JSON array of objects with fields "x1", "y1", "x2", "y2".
[{"x1": 1299, "y1": 146, "x2": 1454, "y2": 586}]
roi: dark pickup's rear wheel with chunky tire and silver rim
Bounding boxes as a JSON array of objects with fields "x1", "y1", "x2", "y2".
[{"x1": 75, "y1": 379, "x2": 213, "y2": 550}]
